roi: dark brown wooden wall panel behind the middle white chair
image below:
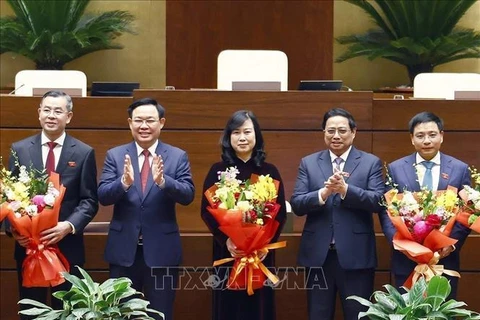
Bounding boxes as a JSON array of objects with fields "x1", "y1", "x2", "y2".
[{"x1": 166, "y1": 0, "x2": 333, "y2": 89}]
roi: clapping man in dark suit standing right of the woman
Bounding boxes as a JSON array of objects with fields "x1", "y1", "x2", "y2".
[{"x1": 291, "y1": 108, "x2": 384, "y2": 320}]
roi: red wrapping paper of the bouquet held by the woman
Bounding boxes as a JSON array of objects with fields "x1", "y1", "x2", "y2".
[{"x1": 205, "y1": 175, "x2": 286, "y2": 295}]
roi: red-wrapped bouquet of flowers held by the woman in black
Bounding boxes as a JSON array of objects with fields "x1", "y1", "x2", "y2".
[{"x1": 205, "y1": 167, "x2": 286, "y2": 295}]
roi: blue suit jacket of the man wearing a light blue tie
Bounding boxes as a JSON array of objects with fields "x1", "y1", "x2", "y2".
[{"x1": 379, "y1": 153, "x2": 470, "y2": 275}]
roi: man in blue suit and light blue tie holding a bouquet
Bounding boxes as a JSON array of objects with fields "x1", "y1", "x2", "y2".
[{"x1": 379, "y1": 112, "x2": 470, "y2": 298}]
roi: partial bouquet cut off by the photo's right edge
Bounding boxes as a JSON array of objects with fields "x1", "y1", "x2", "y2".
[{"x1": 457, "y1": 167, "x2": 480, "y2": 233}]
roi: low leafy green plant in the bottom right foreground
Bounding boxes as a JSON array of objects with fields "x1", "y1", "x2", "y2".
[{"x1": 347, "y1": 276, "x2": 480, "y2": 320}]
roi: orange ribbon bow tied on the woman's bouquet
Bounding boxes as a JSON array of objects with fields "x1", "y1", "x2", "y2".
[{"x1": 213, "y1": 241, "x2": 287, "y2": 296}]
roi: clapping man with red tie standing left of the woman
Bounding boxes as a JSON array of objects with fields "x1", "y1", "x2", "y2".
[{"x1": 98, "y1": 98, "x2": 195, "y2": 320}]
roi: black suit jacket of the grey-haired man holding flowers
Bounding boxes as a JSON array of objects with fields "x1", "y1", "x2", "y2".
[{"x1": 9, "y1": 134, "x2": 98, "y2": 266}]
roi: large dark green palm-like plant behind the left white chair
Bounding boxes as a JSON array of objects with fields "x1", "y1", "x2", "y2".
[{"x1": 0, "y1": 0, "x2": 134, "y2": 70}]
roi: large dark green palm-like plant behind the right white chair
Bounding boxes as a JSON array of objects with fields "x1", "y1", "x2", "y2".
[{"x1": 335, "y1": 0, "x2": 480, "y2": 85}]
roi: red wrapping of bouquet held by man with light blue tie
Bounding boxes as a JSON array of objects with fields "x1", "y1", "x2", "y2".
[{"x1": 385, "y1": 187, "x2": 460, "y2": 289}]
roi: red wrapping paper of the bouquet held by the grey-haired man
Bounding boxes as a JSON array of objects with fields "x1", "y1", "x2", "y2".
[{"x1": 2, "y1": 172, "x2": 70, "y2": 287}]
